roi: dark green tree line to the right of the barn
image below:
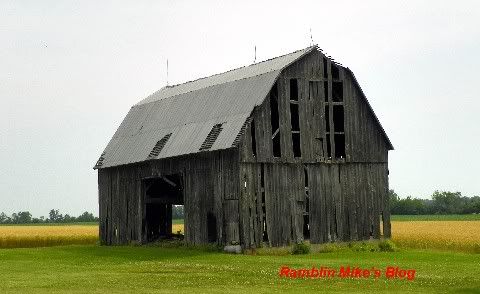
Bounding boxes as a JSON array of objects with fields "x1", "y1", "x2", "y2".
[{"x1": 389, "y1": 190, "x2": 480, "y2": 215}]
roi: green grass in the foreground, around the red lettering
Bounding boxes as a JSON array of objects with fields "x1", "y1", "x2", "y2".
[{"x1": 0, "y1": 245, "x2": 480, "y2": 293}]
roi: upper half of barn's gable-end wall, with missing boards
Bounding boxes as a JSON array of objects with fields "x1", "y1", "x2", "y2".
[{"x1": 240, "y1": 51, "x2": 388, "y2": 163}]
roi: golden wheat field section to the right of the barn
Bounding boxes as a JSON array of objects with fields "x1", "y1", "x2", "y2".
[{"x1": 392, "y1": 221, "x2": 480, "y2": 253}]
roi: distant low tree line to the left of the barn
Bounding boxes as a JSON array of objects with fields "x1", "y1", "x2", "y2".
[{"x1": 0, "y1": 209, "x2": 98, "y2": 224}]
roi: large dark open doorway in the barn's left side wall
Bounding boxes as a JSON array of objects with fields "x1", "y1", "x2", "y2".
[{"x1": 142, "y1": 174, "x2": 184, "y2": 242}]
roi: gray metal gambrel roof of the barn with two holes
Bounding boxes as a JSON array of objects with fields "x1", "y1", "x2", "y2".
[{"x1": 95, "y1": 47, "x2": 315, "y2": 168}]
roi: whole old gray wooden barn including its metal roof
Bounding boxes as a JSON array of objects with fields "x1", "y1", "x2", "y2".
[{"x1": 94, "y1": 46, "x2": 393, "y2": 248}]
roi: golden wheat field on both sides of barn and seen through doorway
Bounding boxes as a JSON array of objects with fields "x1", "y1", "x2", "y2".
[{"x1": 0, "y1": 221, "x2": 480, "y2": 253}]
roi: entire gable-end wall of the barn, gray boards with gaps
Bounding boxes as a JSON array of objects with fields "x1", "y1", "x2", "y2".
[{"x1": 239, "y1": 52, "x2": 390, "y2": 247}]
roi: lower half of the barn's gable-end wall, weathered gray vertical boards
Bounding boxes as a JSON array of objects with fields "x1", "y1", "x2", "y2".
[{"x1": 239, "y1": 163, "x2": 390, "y2": 247}]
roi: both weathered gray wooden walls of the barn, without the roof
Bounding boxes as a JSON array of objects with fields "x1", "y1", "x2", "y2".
[{"x1": 98, "y1": 51, "x2": 391, "y2": 247}]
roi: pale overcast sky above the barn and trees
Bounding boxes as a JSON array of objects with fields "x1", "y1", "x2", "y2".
[{"x1": 0, "y1": 0, "x2": 480, "y2": 216}]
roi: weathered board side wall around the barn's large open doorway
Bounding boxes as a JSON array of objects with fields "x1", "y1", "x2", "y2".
[{"x1": 98, "y1": 150, "x2": 239, "y2": 245}]
